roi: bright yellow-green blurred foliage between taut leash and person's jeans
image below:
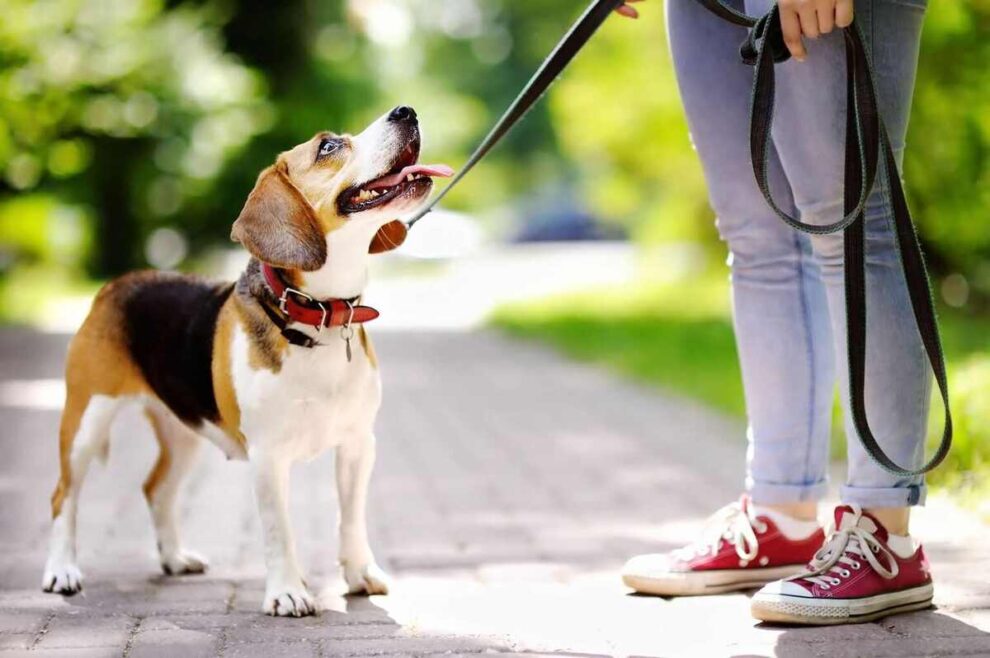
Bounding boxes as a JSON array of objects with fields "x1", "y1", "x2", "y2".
[{"x1": 550, "y1": 3, "x2": 715, "y2": 244}]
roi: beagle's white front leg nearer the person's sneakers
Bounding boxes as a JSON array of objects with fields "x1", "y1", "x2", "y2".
[{"x1": 336, "y1": 434, "x2": 388, "y2": 594}]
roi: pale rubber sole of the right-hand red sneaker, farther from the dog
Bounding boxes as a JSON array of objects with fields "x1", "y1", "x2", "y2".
[{"x1": 751, "y1": 583, "x2": 934, "y2": 626}]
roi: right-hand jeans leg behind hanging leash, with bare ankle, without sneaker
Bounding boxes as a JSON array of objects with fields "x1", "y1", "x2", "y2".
[{"x1": 747, "y1": 0, "x2": 931, "y2": 516}]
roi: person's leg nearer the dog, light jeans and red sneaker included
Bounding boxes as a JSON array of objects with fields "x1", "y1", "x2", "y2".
[{"x1": 623, "y1": 0, "x2": 833, "y2": 595}]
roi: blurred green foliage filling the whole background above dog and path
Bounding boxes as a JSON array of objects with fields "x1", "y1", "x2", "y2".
[{"x1": 0, "y1": 0, "x2": 990, "y2": 309}]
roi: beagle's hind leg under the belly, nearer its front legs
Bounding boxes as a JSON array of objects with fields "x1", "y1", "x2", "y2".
[{"x1": 144, "y1": 403, "x2": 207, "y2": 576}]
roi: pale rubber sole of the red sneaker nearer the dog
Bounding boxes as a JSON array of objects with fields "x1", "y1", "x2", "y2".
[{"x1": 622, "y1": 564, "x2": 806, "y2": 596}]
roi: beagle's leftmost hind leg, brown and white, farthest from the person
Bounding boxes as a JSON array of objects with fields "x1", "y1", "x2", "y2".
[{"x1": 42, "y1": 384, "x2": 121, "y2": 595}]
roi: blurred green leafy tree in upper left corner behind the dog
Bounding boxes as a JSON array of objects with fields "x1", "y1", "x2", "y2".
[{"x1": 0, "y1": 0, "x2": 270, "y2": 275}]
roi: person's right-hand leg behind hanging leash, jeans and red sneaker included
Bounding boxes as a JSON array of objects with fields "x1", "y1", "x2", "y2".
[{"x1": 747, "y1": 0, "x2": 933, "y2": 624}]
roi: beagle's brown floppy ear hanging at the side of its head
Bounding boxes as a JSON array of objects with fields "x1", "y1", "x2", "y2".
[{"x1": 230, "y1": 163, "x2": 327, "y2": 272}]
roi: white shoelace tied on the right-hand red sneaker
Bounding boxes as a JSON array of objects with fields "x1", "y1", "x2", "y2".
[{"x1": 795, "y1": 505, "x2": 899, "y2": 589}]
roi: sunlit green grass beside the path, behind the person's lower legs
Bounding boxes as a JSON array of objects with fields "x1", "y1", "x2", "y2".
[{"x1": 492, "y1": 274, "x2": 990, "y2": 514}]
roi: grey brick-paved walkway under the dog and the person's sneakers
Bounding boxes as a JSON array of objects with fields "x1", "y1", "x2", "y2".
[{"x1": 0, "y1": 330, "x2": 990, "y2": 658}]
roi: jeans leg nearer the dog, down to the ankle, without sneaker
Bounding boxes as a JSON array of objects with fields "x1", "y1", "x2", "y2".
[{"x1": 667, "y1": 0, "x2": 834, "y2": 508}]
